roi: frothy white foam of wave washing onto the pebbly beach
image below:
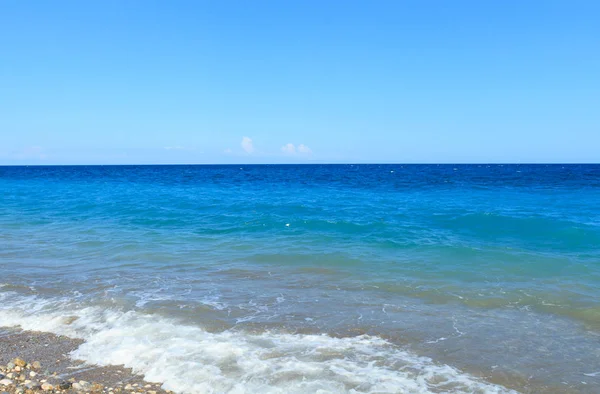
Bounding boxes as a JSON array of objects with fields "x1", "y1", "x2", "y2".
[{"x1": 0, "y1": 292, "x2": 514, "y2": 394}]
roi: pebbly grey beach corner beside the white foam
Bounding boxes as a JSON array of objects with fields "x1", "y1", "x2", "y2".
[{"x1": 0, "y1": 327, "x2": 173, "y2": 394}]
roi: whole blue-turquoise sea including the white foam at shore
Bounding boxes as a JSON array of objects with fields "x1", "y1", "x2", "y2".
[{"x1": 0, "y1": 164, "x2": 600, "y2": 393}]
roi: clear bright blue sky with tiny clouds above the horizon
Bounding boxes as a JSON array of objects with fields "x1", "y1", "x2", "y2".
[{"x1": 0, "y1": 0, "x2": 600, "y2": 165}]
